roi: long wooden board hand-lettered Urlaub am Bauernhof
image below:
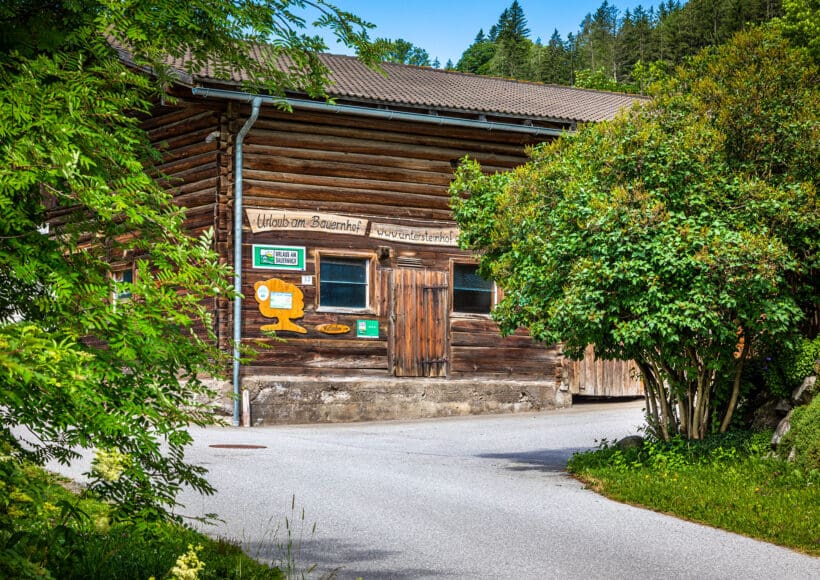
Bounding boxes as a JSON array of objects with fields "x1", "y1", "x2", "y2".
[{"x1": 245, "y1": 208, "x2": 368, "y2": 236}]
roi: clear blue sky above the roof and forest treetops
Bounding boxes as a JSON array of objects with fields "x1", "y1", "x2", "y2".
[{"x1": 314, "y1": 0, "x2": 656, "y2": 66}]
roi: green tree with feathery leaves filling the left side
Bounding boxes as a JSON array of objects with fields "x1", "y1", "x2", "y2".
[{"x1": 0, "y1": 0, "x2": 376, "y2": 536}]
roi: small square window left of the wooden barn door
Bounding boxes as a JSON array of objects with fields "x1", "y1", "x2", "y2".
[{"x1": 319, "y1": 256, "x2": 370, "y2": 309}]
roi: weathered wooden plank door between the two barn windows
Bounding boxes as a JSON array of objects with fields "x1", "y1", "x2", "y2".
[{"x1": 392, "y1": 268, "x2": 449, "y2": 377}]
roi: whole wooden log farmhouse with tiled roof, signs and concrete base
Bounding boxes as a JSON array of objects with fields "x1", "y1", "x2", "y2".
[{"x1": 136, "y1": 55, "x2": 642, "y2": 424}]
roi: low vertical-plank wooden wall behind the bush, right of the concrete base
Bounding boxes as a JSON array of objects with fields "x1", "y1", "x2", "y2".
[{"x1": 570, "y1": 346, "x2": 644, "y2": 397}]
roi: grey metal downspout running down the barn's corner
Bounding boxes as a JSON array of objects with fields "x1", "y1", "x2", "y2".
[{"x1": 233, "y1": 97, "x2": 262, "y2": 427}]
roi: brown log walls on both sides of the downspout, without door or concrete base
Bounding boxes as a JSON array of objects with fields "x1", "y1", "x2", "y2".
[{"x1": 147, "y1": 101, "x2": 561, "y2": 380}]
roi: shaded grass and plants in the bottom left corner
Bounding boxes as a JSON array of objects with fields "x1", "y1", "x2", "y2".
[{"x1": 0, "y1": 465, "x2": 285, "y2": 580}]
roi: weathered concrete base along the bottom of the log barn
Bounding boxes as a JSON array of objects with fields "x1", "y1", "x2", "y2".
[{"x1": 216, "y1": 376, "x2": 572, "y2": 425}]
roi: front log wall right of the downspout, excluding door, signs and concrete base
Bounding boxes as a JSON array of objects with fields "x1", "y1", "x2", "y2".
[{"x1": 231, "y1": 108, "x2": 556, "y2": 372}]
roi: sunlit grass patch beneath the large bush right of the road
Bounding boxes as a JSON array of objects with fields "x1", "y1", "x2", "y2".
[{"x1": 568, "y1": 433, "x2": 820, "y2": 556}]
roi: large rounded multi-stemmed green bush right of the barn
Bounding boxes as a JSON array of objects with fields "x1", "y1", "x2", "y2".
[{"x1": 451, "y1": 27, "x2": 820, "y2": 438}]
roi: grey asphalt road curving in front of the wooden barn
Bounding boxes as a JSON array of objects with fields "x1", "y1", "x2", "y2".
[{"x1": 173, "y1": 402, "x2": 820, "y2": 580}]
